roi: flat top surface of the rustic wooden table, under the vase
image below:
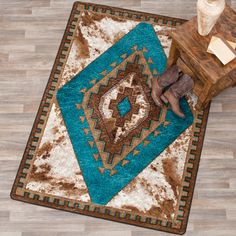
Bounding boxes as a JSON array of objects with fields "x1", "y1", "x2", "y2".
[{"x1": 172, "y1": 5, "x2": 236, "y2": 83}]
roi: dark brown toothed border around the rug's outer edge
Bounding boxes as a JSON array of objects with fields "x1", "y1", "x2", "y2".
[{"x1": 10, "y1": 2, "x2": 210, "y2": 234}]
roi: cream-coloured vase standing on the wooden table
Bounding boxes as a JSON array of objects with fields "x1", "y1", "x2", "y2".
[{"x1": 197, "y1": 0, "x2": 225, "y2": 36}]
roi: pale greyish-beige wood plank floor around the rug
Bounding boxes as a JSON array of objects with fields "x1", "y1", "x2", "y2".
[{"x1": 0, "y1": 0, "x2": 236, "y2": 236}]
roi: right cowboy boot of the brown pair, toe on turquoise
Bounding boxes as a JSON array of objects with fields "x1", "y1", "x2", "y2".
[{"x1": 161, "y1": 74, "x2": 194, "y2": 118}]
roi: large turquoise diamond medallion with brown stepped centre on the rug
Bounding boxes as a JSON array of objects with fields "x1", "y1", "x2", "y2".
[{"x1": 57, "y1": 23, "x2": 193, "y2": 205}]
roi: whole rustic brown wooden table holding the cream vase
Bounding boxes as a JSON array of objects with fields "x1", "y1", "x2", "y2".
[{"x1": 168, "y1": 6, "x2": 236, "y2": 109}]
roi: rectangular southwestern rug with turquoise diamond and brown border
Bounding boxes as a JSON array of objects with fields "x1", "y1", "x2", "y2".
[{"x1": 11, "y1": 2, "x2": 209, "y2": 234}]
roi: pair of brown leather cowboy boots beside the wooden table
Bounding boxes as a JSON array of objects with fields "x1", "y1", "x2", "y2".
[{"x1": 152, "y1": 65, "x2": 194, "y2": 118}]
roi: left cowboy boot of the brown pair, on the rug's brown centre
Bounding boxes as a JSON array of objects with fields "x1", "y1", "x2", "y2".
[{"x1": 152, "y1": 65, "x2": 179, "y2": 106}]
